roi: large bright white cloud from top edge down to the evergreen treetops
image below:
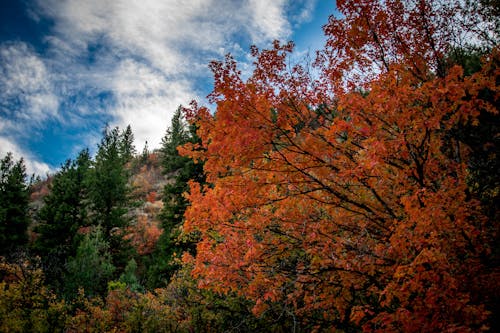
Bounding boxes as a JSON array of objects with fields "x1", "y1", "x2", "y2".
[{"x1": 31, "y1": 0, "x2": 298, "y2": 147}]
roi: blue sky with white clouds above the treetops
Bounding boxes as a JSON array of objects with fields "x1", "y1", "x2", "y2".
[{"x1": 0, "y1": 0, "x2": 335, "y2": 177}]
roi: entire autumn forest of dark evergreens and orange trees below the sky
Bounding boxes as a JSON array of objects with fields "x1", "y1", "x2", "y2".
[{"x1": 0, "y1": 0, "x2": 500, "y2": 332}]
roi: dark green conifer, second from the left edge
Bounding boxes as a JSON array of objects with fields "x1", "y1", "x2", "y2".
[{"x1": 34, "y1": 150, "x2": 91, "y2": 287}]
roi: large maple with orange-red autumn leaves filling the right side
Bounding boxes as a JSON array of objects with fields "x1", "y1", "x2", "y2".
[{"x1": 181, "y1": 0, "x2": 499, "y2": 332}]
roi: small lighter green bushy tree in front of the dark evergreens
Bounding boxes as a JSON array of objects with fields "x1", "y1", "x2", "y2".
[{"x1": 65, "y1": 227, "x2": 115, "y2": 298}]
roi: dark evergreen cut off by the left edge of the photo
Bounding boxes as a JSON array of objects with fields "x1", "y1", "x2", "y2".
[{"x1": 0, "y1": 153, "x2": 30, "y2": 255}]
